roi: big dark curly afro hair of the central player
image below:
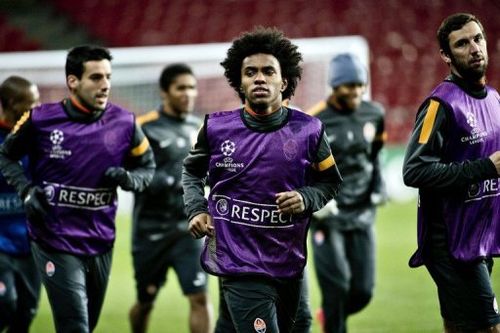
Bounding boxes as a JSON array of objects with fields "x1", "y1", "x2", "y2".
[{"x1": 220, "y1": 26, "x2": 302, "y2": 102}]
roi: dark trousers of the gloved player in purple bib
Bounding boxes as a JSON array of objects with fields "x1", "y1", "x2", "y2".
[{"x1": 31, "y1": 242, "x2": 112, "y2": 333}]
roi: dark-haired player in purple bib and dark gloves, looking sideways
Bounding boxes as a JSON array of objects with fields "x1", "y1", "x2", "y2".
[{"x1": 0, "y1": 45, "x2": 155, "y2": 333}]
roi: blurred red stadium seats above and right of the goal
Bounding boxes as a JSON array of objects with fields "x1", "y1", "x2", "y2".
[{"x1": 0, "y1": 0, "x2": 500, "y2": 144}]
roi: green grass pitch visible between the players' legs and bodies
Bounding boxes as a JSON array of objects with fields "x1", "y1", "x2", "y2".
[{"x1": 31, "y1": 198, "x2": 500, "y2": 333}]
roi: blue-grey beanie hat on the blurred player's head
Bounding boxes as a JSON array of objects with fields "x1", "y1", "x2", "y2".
[{"x1": 328, "y1": 53, "x2": 368, "y2": 88}]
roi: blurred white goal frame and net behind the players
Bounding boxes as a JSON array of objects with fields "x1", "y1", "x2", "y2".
[{"x1": 0, "y1": 36, "x2": 369, "y2": 115}]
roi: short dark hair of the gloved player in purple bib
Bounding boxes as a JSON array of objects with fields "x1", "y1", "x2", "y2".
[{"x1": 66, "y1": 45, "x2": 113, "y2": 79}]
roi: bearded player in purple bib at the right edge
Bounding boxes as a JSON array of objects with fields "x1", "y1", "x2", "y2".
[{"x1": 403, "y1": 13, "x2": 500, "y2": 333}]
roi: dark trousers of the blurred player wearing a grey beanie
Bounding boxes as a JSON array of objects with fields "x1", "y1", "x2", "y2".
[{"x1": 312, "y1": 223, "x2": 375, "y2": 333}]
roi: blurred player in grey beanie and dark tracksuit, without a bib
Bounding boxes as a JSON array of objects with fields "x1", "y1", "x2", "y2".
[{"x1": 307, "y1": 53, "x2": 386, "y2": 333}]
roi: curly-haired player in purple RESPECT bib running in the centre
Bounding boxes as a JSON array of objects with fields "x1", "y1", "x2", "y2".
[{"x1": 182, "y1": 27, "x2": 341, "y2": 333}]
